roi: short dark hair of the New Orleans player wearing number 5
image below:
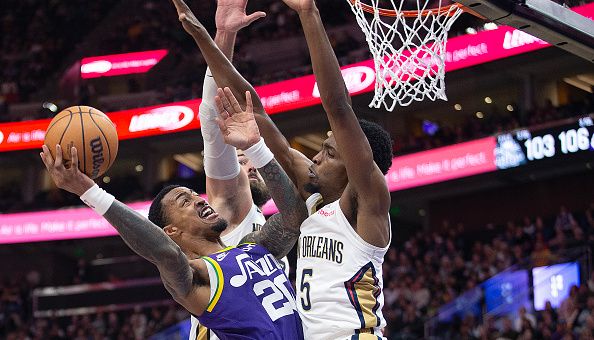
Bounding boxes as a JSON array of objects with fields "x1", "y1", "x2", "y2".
[{"x1": 359, "y1": 119, "x2": 393, "y2": 175}]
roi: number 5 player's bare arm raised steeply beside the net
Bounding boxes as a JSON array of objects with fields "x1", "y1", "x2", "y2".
[{"x1": 283, "y1": 0, "x2": 390, "y2": 247}]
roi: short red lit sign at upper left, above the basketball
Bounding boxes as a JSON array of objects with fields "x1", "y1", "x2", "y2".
[{"x1": 80, "y1": 50, "x2": 167, "y2": 79}]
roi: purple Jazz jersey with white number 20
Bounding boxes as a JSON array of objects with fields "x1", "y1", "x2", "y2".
[{"x1": 198, "y1": 243, "x2": 303, "y2": 340}]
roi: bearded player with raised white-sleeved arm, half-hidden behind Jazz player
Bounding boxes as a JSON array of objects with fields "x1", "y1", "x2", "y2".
[{"x1": 176, "y1": 0, "x2": 289, "y2": 340}]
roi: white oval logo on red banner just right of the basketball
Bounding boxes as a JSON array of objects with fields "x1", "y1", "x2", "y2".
[{"x1": 128, "y1": 105, "x2": 194, "y2": 132}]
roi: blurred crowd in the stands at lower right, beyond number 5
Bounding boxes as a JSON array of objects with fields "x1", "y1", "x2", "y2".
[{"x1": 383, "y1": 202, "x2": 594, "y2": 340}]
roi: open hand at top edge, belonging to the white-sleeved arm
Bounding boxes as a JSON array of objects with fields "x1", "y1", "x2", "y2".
[{"x1": 215, "y1": 0, "x2": 266, "y2": 32}]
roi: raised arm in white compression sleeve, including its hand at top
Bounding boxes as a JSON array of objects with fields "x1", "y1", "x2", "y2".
[{"x1": 199, "y1": 0, "x2": 265, "y2": 225}]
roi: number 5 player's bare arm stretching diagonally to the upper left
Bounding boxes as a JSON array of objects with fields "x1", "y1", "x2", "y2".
[{"x1": 172, "y1": 0, "x2": 311, "y2": 195}]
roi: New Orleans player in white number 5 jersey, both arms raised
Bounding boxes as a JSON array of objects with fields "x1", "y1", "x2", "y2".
[{"x1": 169, "y1": 0, "x2": 392, "y2": 340}]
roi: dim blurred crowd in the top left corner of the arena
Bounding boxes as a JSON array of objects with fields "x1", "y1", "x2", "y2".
[{"x1": 0, "y1": 0, "x2": 116, "y2": 106}]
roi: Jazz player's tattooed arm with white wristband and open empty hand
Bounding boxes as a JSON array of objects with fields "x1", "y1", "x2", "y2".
[{"x1": 216, "y1": 88, "x2": 307, "y2": 258}]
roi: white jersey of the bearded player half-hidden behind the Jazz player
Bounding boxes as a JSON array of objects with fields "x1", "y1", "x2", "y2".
[{"x1": 189, "y1": 204, "x2": 289, "y2": 340}]
